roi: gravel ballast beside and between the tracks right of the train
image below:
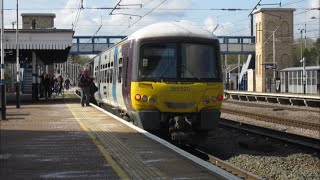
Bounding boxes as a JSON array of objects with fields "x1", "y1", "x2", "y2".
[{"x1": 205, "y1": 100, "x2": 320, "y2": 180}]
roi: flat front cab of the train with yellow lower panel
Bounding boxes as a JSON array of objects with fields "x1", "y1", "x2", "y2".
[{"x1": 128, "y1": 38, "x2": 223, "y2": 143}]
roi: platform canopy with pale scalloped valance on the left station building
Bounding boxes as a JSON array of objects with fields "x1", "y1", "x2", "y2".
[{"x1": 3, "y1": 29, "x2": 74, "y2": 65}]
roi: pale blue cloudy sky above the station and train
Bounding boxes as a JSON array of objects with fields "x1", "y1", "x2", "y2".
[{"x1": 3, "y1": 0, "x2": 320, "y2": 39}]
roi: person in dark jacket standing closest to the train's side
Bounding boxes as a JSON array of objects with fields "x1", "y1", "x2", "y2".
[{"x1": 78, "y1": 68, "x2": 91, "y2": 107}]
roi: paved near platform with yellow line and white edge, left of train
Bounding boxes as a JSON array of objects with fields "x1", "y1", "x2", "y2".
[{"x1": 0, "y1": 91, "x2": 238, "y2": 179}]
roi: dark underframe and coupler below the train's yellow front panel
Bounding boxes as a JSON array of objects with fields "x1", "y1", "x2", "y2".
[{"x1": 130, "y1": 110, "x2": 221, "y2": 145}]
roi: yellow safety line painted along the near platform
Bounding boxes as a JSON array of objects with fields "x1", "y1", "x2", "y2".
[{"x1": 67, "y1": 104, "x2": 129, "y2": 179}]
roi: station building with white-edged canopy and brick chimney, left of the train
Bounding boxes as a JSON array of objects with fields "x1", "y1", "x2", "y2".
[{"x1": 3, "y1": 13, "x2": 74, "y2": 100}]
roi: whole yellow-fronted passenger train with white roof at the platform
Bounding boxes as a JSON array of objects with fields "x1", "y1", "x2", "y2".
[{"x1": 90, "y1": 22, "x2": 223, "y2": 144}]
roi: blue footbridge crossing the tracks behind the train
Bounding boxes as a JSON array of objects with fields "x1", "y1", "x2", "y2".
[{"x1": 69, "y1": 36, "x2": 255, "y2": 55}]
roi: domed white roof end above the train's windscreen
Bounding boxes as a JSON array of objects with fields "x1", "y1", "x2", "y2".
[{"x1": 128, "y1": 22, "x2": 217, "y2": 40}]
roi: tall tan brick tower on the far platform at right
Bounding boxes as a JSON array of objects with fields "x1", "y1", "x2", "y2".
[{"x1": 254, "y1": 8, "x2": 295, "y2": 92}]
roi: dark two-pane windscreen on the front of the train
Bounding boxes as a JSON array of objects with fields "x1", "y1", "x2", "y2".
[{"x1": 139, "y1": 43, "x2": 220, "y2": 81}]
